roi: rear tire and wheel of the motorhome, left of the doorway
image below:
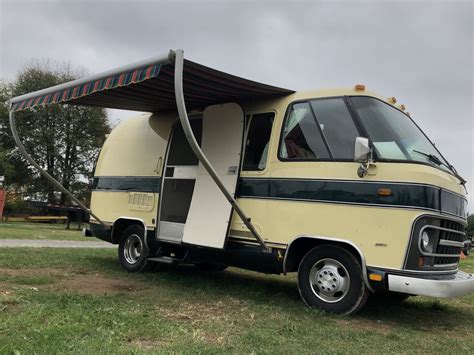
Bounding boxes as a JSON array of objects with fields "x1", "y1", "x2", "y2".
[{"x1": 118, "y1": 224, "x2": 153, "y2": 272}]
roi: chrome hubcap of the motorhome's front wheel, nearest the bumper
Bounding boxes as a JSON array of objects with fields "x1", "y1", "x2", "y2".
[{"x1": 309, "y1": 259, "x2": 351, "y2": 303}]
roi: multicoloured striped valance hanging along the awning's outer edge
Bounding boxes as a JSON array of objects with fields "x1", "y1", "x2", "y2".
[{"x1": 11, "y1": 64, "x2": 161, "y2": 111}]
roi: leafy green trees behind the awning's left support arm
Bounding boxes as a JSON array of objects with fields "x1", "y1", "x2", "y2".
[{"x1": 0, "y1": 63, "x2": 110, "y2": 203}]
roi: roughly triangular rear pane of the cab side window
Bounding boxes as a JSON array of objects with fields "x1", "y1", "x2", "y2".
[{"x1": 280, "y1": 102, "x2": 330, "y2": 160}]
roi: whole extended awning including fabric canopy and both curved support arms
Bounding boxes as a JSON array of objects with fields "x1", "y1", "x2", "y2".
[{"x1": 9, "y1": 49, "x2": 286, "y2": 252}]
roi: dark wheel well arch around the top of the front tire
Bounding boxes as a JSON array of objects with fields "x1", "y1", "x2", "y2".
[{"x1": 283, "y1": 237, "x2": 364, "y2": 272}]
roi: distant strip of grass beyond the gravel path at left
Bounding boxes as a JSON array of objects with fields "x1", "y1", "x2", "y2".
[{"x1": 0, "y1": 222, "x2": 97, "y2": 241}]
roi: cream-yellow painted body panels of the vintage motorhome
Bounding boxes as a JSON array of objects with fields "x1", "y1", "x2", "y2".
[{"x1": 91, "y1": 90, "x2": 465, "y2": 270}]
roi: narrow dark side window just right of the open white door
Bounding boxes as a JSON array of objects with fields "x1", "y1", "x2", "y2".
[{"x1": 242, "y1": 113, "x2": 275, "y2": 171}]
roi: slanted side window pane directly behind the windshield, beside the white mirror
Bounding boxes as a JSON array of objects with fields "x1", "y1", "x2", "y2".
[{"x1": 311, "y1": 98, "x2": 359, "y2": 159}]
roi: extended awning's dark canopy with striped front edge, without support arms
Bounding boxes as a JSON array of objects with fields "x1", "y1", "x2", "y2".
[{"x1": 10, "y1": 51, "x2": 294, "y2": 112}]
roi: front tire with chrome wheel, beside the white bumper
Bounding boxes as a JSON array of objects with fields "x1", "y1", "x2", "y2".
[{"x1": 298, "y1": 245, "x2": 369, "y2": 315}]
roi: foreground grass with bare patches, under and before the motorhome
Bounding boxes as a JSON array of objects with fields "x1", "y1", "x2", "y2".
[{"x1": 0, "y1": 225, "x2": 474, "y2": 354}]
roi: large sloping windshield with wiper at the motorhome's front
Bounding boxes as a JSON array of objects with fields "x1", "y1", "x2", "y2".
[{"x1": 351, "y1": 96, "x2": 449, "y2": 170}]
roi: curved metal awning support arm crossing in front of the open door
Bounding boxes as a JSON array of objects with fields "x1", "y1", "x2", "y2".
[{"x1": 170, "y1": 49, "x2": 270, "y2": 252}]
